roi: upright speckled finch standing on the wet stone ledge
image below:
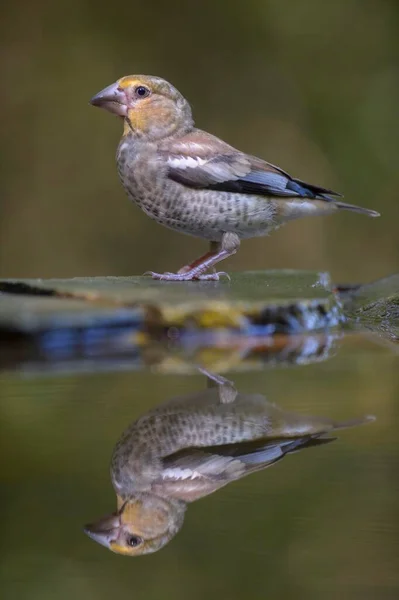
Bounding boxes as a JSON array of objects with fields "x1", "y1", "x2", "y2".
[{"x1": 90, "y1": 75, "x2": 380, "y2": 281}]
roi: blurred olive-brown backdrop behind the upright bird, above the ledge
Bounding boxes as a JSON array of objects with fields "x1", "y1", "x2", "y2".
[{"x1": 0, "y1": 0, "x2": 399, "y2": 281}]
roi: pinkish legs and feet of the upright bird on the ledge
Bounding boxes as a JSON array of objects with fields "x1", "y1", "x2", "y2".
[{"x1": 148, "y1": 233, "x2": 240, "y2": 281}]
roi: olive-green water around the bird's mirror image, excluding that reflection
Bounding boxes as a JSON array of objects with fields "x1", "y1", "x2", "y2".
[{"x1": 0, "y1": 335, "x2": 399, "y2": 600}]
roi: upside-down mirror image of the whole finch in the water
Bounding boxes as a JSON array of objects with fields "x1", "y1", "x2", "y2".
[{"x1": 85, "y1": 376, "x2": 372, "y2": 556}]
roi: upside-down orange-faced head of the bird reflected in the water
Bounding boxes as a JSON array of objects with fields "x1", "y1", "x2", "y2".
[{"x1": 84, "y1": 494, "x2": 186, "y2": 556}]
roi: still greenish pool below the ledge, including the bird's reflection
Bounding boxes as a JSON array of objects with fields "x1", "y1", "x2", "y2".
[{"x1": 0, "y1": 335, "x2": 399, "y2": 600}]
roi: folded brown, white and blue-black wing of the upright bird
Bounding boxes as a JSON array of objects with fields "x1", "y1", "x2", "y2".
[{"x1": 158, "y1": 129, "x2": 340, "y2": 201}]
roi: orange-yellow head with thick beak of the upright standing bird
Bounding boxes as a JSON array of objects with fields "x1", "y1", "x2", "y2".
[{"x1": 90, "y1": 75, "x2": 193, "y2": 140}]
